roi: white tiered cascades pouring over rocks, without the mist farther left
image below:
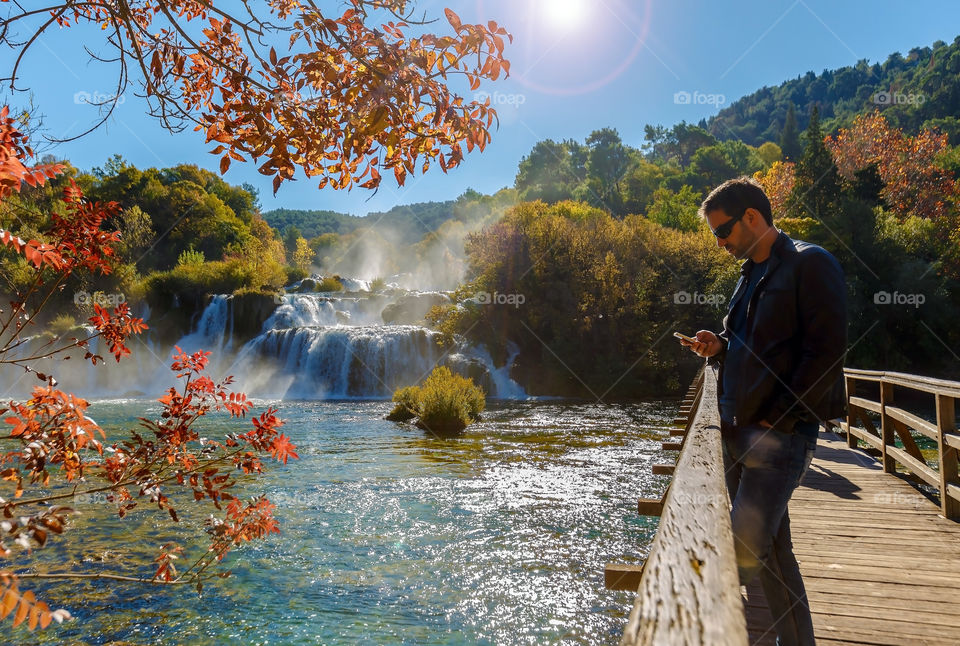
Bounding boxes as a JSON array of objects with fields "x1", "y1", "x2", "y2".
[{"x1": 167, "y1": 290, "x2": 526, "y2": 399}]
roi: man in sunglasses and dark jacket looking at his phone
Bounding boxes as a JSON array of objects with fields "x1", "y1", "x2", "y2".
[{"x1": 684, "y1": 177, "x2": 847, "y2": 646}]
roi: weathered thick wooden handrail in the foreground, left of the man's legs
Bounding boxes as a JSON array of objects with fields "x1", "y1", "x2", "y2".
[{"x1": 620, "y1": 367, "x2": 747, "y2": 646}]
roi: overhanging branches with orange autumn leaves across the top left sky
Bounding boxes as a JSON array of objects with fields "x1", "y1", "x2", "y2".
[{"x1": 0, "y1": 0, "x2": 512, "y2": 192}]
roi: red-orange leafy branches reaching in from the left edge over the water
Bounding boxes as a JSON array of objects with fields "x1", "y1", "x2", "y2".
[{"x1": 0, "y1": 107, "x2": 297, "y2": 630}]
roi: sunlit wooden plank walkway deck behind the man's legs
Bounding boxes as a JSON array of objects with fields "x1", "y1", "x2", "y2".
[{"x1": 746, "y1": 431, "x2": 960, "y2": 646}]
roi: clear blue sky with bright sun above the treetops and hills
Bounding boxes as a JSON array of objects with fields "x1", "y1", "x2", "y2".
[{"x1": 0, "y1": 0, "x2": 960, "y2": 215}]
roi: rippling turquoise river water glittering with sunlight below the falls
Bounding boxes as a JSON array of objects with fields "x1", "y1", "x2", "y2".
[{"x1": 13, "y1": 400, "x2": 676, "y2": 646}]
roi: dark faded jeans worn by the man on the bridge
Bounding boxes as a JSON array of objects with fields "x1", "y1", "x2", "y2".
[{"x1": 723, "y1": 423, "x2": 817, "y2": 646}]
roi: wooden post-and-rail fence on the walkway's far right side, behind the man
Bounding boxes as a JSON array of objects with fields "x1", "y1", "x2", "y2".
[{"x1": 837, "y1": 368, "x2": 960, "y2": 520}]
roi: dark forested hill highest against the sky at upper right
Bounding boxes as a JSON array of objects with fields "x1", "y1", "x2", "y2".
[{"x1": 706, "y1": 36, "x2": 960, "y2": 146}]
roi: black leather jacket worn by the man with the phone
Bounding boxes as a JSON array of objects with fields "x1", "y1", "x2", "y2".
[{"x1": 709, "y1": 231, "x2": 847, "y2": 432}]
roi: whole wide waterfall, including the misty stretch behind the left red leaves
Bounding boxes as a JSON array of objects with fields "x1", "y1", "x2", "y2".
[{"x1": 31, "y1": 288, "x2": 526, "y2": 399}]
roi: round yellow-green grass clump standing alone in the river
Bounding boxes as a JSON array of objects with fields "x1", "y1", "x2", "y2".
[{"x1": 387, "y1": 366, "x2": 485, "y2": 434}]
